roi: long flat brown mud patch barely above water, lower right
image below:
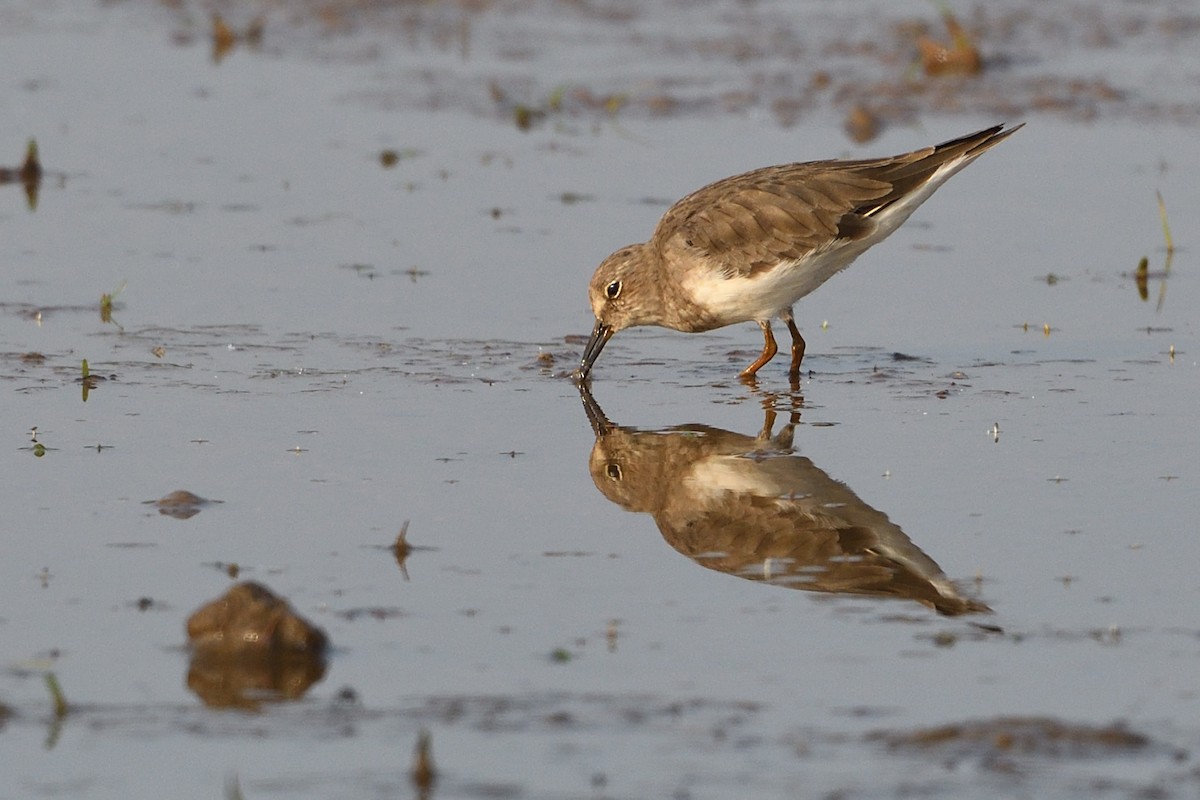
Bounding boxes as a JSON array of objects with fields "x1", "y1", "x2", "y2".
[{"x1": 868, "y1": 717, "x2": 1151, "y2": 766}]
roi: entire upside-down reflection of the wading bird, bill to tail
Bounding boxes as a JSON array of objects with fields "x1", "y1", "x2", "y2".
[{"x1": 581, "y1": 387, "x2": 991, "y2": 615}]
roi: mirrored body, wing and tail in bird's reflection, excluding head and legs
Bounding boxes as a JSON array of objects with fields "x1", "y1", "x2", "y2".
[{"x1": 655, "y1": 456, "x2": 988, "y2": 614}]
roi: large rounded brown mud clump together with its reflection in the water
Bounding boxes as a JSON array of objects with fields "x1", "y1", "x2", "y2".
[{"x1": 187, "y1": 582, "x2": 328, "y2": 708}]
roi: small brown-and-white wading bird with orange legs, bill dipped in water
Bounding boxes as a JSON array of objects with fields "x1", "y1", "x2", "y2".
[{"x1": 576, "y1": 125, "x2": 1021, "y2": 383}]
